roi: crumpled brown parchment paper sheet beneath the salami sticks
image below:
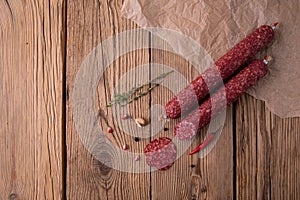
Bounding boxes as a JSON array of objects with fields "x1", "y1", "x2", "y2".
[{"x1": 122, "y1": 0, "x2": 300, "y2": 117}]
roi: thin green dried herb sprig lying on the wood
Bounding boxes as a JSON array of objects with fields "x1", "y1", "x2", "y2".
[{"x1": 106, "y1": 70, "x2": 174, "y2": 107}]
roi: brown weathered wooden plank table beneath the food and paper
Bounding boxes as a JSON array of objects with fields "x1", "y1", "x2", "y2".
[{"x1": 0, "y1": 0, "x2": 300, "y2": 199}]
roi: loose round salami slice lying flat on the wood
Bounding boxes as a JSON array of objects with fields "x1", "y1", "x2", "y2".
[{"x1": 144, "y1": 137, "x2": 177, "y2": 170}]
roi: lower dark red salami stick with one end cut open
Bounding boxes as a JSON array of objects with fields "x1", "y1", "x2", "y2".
[{"x1": 174, "y1": 57, "x2": 270, "y2": 140}]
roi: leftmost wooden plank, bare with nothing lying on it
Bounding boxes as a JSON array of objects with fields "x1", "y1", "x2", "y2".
[{"x1": 0, "y1": 0, "x2": 65, "y2": 199}]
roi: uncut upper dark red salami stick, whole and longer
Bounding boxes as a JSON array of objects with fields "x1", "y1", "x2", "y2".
[{"x1": 165, "y1": 23, "x2": 278, "y2": 119}]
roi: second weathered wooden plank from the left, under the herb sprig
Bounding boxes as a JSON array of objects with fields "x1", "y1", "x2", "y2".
[{"x1": 67, "y1": 0, "x2": 150, "y2": 199}]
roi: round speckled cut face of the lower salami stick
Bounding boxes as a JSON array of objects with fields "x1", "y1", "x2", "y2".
[{"x1": 174, "y1": 120, "x2": 198, "y2": 140}]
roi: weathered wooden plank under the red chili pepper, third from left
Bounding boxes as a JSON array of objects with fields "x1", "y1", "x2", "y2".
[{"x1": 151, "y1": 44, "x2": 233, "y2": 199}]
